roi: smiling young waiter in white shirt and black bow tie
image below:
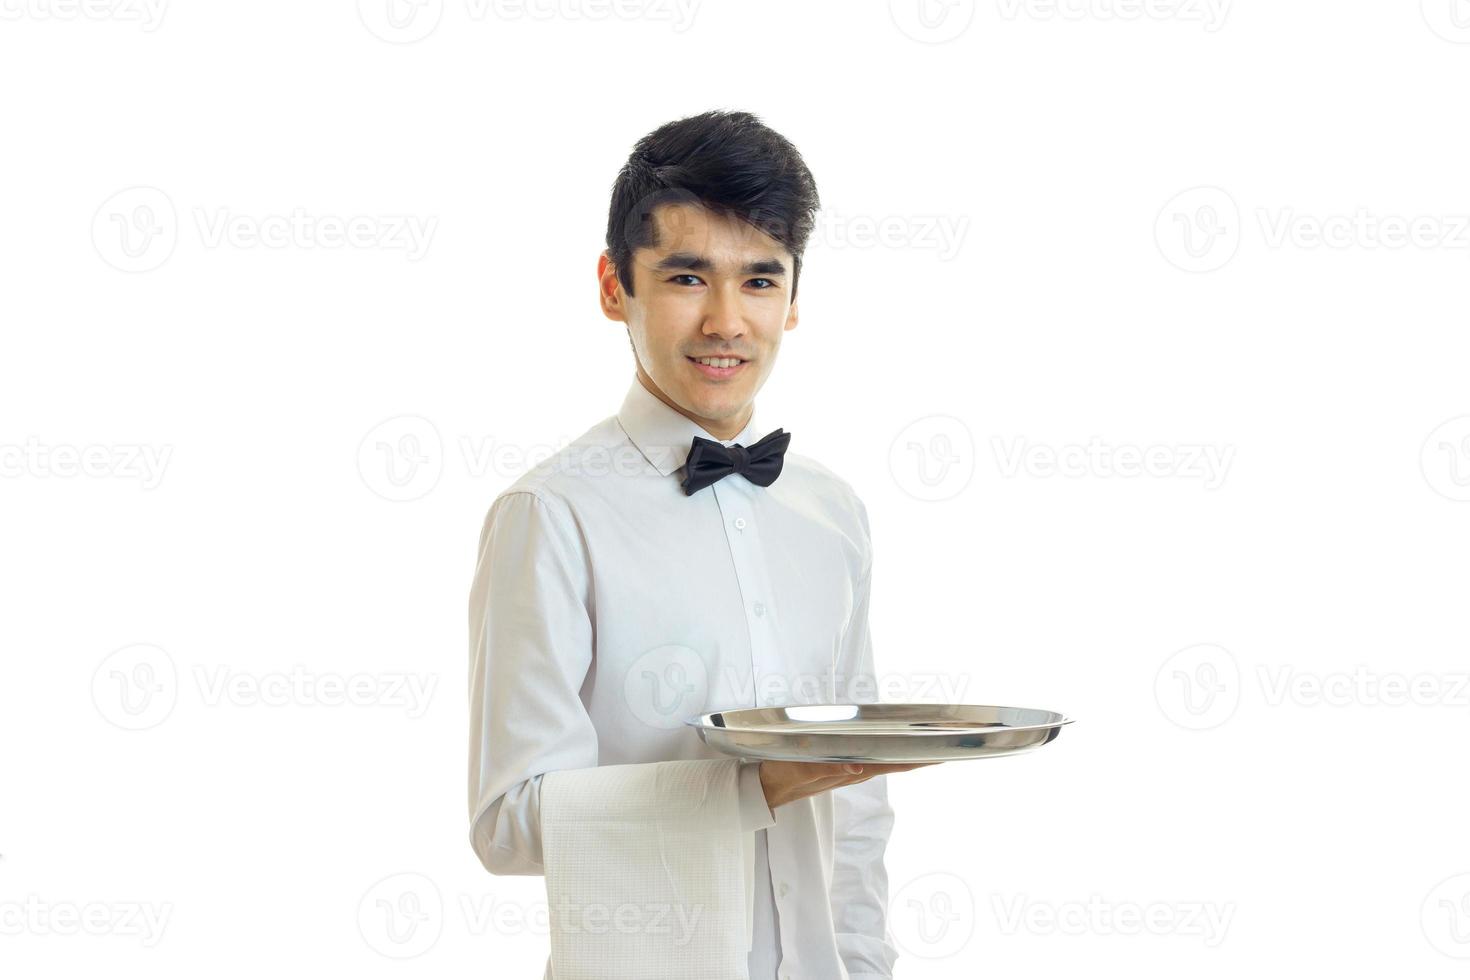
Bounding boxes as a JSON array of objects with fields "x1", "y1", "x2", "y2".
[{"x1": 469, "y1": 112, "x2": 914, "y2": 980}]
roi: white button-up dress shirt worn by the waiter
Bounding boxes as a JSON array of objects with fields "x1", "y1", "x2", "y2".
[{"x1": 469, "y1": 376, "x2": 897, "y2": 980}]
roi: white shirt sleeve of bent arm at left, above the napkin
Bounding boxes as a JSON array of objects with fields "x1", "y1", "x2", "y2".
[{"x1": 469, "y1": 489, "x2": 598, "y2": 874}]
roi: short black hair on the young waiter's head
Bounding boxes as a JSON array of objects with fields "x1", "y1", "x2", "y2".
[{"x1": 607, "y1": 110, "x2": 822, "y2": 300}]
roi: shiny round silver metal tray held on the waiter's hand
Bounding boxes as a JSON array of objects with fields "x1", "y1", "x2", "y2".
[{"x1": 685, "y1": 704, "x2": 1072, "y2": 763}]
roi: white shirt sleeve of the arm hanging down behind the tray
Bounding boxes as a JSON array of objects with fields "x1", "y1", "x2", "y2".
[{"x1": 831, "y1": 501, "x2": 898, "y2": 980}]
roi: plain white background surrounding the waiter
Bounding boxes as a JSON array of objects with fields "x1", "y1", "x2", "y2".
[{"x1": 0, "y1": 0, "x2": 1470, "y2": 980}]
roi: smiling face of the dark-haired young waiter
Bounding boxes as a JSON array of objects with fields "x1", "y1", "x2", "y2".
[{"x1": 597, "y1": 204, "x2": 797, "y2": 439}]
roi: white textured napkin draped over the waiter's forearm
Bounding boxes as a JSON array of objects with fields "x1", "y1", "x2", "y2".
[{"x1": 541, "y1": 760, "x2": 770, "y2": 980}]
